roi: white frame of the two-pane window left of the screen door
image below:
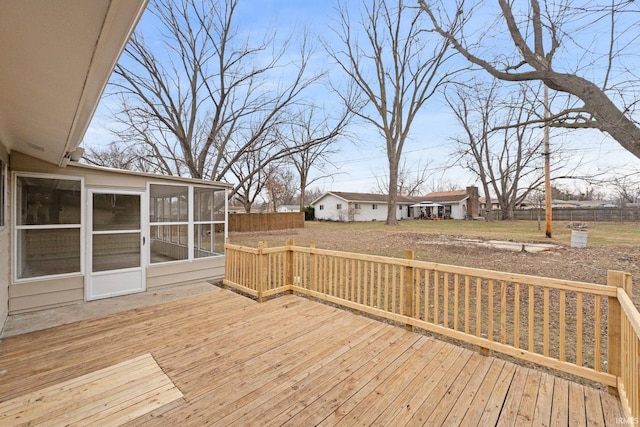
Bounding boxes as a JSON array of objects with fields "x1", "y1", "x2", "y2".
[{"x1": 11, "y1": 171, "x2": 86, "y2": 284}]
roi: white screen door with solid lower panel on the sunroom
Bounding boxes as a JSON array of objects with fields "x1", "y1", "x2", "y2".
[{"x1": 85, "y1": 190, "x2": 146, "y2": 301}]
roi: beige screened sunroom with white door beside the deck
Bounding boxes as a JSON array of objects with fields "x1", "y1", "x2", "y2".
[{"x1": 9, "y1": 152, "x2": 228, "y2": 313}]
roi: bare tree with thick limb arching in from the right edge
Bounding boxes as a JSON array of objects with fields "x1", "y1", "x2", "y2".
[{"x1": 418, "y1": 0, "x2": 640, "y2": 157}]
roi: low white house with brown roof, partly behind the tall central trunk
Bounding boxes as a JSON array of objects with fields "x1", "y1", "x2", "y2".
[{"x1": 311, "y1": 191, "x2": 418, "y2": 222}]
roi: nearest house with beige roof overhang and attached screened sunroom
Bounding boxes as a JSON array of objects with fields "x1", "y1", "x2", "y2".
[{"x1": 0, "y1": 0, "x2": 229, "y2": 327}]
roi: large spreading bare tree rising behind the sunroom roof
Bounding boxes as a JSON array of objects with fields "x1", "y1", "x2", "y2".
[{"x1": 102, "y1": 0, "x2": 330, "y2": 193}]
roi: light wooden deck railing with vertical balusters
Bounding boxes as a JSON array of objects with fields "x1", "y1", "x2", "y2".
[{"x1": 224, "y1": 241, "x2": 640, "y2": 417}]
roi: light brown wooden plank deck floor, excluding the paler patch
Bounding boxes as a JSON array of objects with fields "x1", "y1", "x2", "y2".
[{"x1": 0, "y1": 290, "x2": 623, "y2": 426}]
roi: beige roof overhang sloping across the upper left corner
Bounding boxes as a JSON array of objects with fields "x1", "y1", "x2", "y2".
[{"x1": 0, "y1": 0, "x2": 148, "y2": 166}]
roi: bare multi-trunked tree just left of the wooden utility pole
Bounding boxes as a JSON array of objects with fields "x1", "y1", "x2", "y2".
[{"x1": 445, "y1": 81, "x2": 557, "y2": 221}]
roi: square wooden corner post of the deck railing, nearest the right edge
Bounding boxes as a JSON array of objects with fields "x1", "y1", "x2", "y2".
[{"x1": 607, "y1": 270, "x2": 626, "y2": 394}]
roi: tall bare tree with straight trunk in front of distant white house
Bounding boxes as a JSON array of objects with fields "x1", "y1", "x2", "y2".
[{"x1": 326, "y1": 0, "x2": 458, "y2": 225}]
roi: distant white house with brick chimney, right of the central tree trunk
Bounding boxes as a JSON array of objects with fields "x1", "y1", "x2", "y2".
[{"x1": 411, "y1": 187, "x2": 480, "y2": 219}]
